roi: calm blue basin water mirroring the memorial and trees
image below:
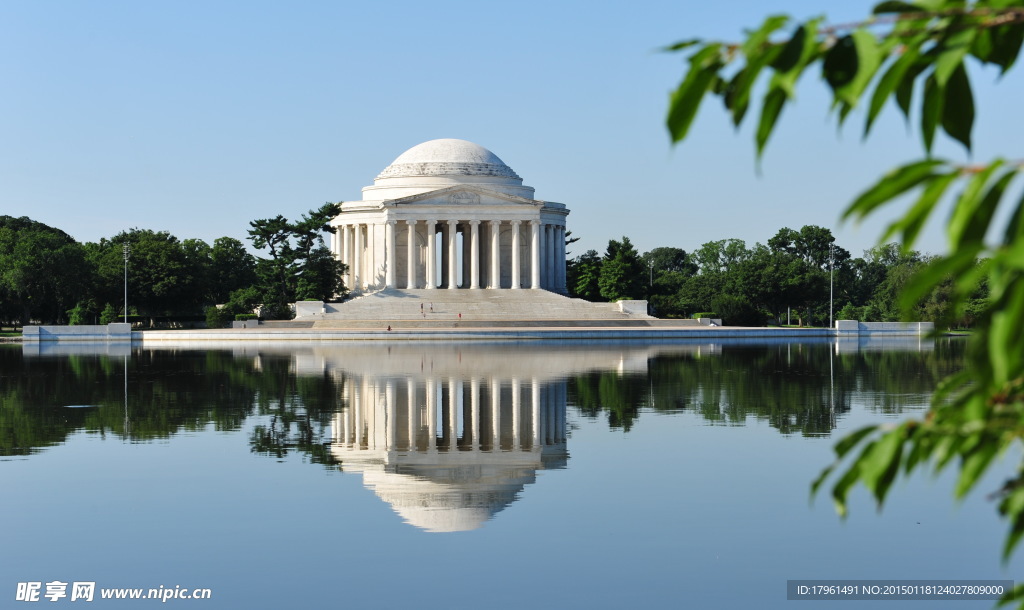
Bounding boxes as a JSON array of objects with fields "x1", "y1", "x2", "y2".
[{"x1": 0, "y1": 339, "x2": 1022, "y2": 609}]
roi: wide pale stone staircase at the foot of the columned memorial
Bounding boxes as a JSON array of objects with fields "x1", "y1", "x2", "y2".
[{"x1": 266, "y1": 289, "x2": 696, "y2": 329}]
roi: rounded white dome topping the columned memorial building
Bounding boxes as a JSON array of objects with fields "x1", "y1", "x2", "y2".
[{"x1": 377, "y1": 139, "x2": 521, "y2": 180}]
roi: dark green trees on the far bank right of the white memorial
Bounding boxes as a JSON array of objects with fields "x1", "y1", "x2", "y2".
[{"x1": 566, "y1": 225, "x2": 988, "y2": 328}]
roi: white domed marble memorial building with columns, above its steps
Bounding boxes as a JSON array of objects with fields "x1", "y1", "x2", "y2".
[{"x1": 331, "y1": 139, "x2": 569, "y2": 294}]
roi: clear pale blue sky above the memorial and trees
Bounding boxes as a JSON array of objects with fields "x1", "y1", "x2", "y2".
[{"x1": 0, "y1": 0, "x2": 1024, "y2": 255}]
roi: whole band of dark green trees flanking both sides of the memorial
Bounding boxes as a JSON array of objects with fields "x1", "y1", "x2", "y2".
[{"x1": 0, "y1": 211, "x2": 987, "y2": 328}]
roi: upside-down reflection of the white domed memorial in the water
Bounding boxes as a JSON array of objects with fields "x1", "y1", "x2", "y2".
[{"x1": 331, "y1": 347, "x2": 571, "y2": 532}]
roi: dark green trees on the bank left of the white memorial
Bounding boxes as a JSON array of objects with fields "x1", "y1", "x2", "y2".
[{"x1": 0, "y1": 204, "x2": 346, "y2": 326}]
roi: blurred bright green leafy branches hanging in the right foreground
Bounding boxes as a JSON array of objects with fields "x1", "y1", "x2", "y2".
[{"x1": 668, "y1": 0, "x2": 1024, "y2": 597}]
